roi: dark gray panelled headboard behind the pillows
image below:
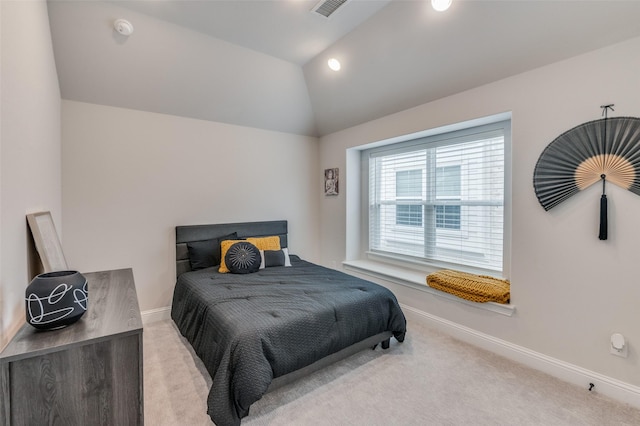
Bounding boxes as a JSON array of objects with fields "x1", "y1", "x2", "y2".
[{"x1": 176, "y1": 220, "x2": 287, "y2": 277}]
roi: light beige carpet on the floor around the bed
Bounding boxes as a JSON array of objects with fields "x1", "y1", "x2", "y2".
[{"x1": 144, "y1": 321, "x2": 640, "y2": 426}]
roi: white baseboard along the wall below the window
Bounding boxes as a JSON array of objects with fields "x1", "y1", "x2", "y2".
[{"x1": 402, "y1": 305, "x2": 640, "y2": 408}]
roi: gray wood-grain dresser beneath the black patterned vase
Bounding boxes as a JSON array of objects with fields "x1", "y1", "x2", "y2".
[{"x1": 0, "y1": 269, "x2": 144, "y2": 426}]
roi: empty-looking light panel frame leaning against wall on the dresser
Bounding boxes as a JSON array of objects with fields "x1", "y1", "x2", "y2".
[{"x1": 27, "y1": 211, "x2": 69, "y2": 272}]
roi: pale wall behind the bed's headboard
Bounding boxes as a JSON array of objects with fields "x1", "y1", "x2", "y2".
[{"x1": 62, "y1": 100, "x2": 322, "y2": 311}]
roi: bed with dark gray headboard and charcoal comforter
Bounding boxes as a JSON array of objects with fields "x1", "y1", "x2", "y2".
[{"x1": 171, "y1": 221, "x2": 406, "y2": 426}]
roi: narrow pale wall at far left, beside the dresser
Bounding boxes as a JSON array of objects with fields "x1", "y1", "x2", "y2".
[{"x1": 0, "y1": 1, "x2": 62, "y2": 349}]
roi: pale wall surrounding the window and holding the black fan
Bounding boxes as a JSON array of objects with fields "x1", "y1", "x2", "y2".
[{"x1": 320, "y1": 38, "x2": 640, "y2": 389}]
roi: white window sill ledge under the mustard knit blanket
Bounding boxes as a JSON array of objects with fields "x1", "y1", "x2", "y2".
[{"x1": 342, "y1": 260, "x2": 516, "y2": 317}]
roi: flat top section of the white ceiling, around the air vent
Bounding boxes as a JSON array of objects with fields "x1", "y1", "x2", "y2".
[{"x1": 118, "y1": 0, "x2": 391, "y2": 65}]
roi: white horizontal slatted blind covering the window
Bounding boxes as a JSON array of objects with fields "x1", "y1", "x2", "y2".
[{"x1": 364, "y1": 123, "x2": 505, "y2": 272}]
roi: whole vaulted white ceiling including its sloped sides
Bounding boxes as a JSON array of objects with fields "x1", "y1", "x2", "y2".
[{"x1": 49, "y1": 0, "x2": 640, "y2": 136}]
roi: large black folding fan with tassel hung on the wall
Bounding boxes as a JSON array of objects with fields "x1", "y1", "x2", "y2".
[{"x1": 533, "y1": 104, "x2": 640, "y2": 240}]
